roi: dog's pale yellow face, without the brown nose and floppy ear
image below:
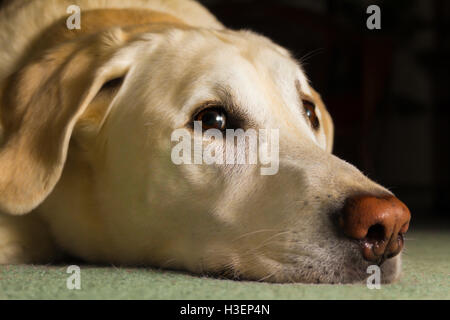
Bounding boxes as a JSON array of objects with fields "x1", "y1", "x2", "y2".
[{"x1": 2, "y1": 29, "x2": 406, "y2": 283}]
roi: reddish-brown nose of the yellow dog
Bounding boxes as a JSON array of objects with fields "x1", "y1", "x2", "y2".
[{"x1": 340, "y1": 196, "x2": 411, "y2": 263}]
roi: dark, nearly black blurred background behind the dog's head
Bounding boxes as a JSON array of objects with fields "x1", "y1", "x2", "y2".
[{"x1": 200, "y1": 0, "x2": 450, "y2": 226}]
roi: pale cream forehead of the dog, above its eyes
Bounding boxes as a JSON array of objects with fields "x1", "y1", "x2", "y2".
[{"x1": 126, "y1": 30, "x2": 311, "y2": 131}]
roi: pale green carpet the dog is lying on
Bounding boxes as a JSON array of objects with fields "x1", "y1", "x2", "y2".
[{"x1": 0, "y1": 230, "x2": 450, "y2": 299}]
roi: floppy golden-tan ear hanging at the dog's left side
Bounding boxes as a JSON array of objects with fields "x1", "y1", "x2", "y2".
[{"x1": 0, "y1": 29, "x2": 133, "y2": 215}]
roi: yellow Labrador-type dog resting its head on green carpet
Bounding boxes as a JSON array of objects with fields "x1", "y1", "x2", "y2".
[{"x1": 0, "y1": 0, "x2": 410, "y2": 283}]
